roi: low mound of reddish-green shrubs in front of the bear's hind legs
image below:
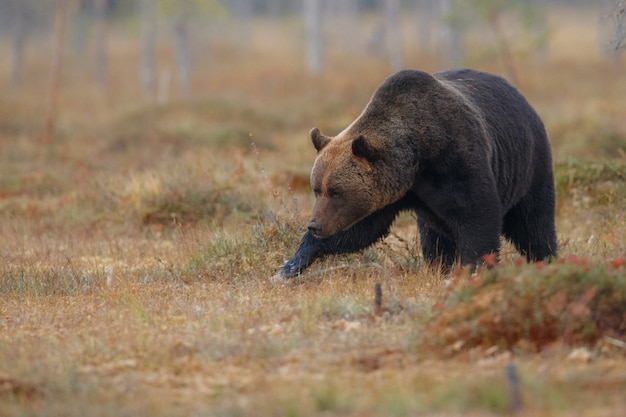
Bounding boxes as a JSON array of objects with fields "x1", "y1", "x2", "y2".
[{"x1": 424, "y1": 257, "x2": 626, "y2": 353}]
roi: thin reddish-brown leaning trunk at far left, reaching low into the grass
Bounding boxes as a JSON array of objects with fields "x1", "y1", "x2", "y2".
[{"x1": 42, "y1": 0, "x2": 69, "y2": 144}]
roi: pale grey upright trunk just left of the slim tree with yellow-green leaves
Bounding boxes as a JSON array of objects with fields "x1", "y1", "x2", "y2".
[{"x1": 140, "y1": 0, "x2": 156, "y2": 99}]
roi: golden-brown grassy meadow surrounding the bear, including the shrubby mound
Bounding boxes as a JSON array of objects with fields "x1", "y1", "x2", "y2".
[{"x1": 0, "y1": 7, "x2": 626, "y2": 417}]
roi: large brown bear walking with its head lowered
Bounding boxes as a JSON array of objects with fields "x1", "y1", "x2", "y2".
[{"x1": 274, "y1": 69, "x2": 557, "y2": 279}]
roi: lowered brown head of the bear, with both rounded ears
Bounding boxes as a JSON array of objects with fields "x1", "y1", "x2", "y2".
[{"x1": 308, "y1": 124, "x2": 410, "y2": 238}]
